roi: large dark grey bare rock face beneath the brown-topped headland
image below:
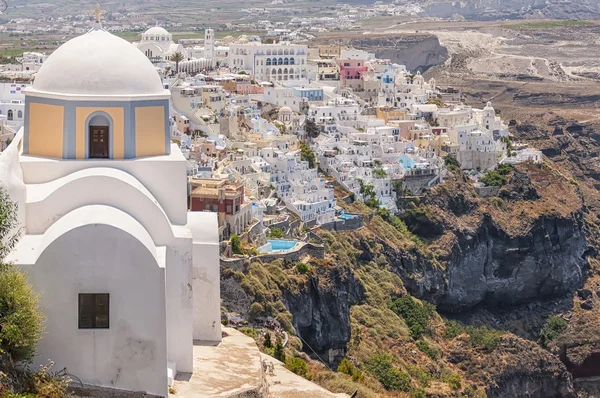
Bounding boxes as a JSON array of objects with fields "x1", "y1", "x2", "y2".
[{"x1": 392, "y1": 213, "x2": 587, "y2": 312}]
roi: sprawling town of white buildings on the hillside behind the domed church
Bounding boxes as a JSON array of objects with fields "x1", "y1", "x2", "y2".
[{"x1": 0, "y1": 26, "x2": 542, "y2": 247}]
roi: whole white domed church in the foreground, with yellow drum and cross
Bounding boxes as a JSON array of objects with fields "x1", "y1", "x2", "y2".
[{"x1": 0, "y1": 9, "x2": 221, "y2": 396}]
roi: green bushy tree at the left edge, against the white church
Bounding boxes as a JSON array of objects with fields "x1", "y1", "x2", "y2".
[{"x1": 0, "y1": 188, "x2": 44, "y2": 362}]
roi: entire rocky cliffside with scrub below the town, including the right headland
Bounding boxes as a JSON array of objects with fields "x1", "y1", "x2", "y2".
[{"x1": 222, "y1": 164, "x2": 600, "y2": 397}]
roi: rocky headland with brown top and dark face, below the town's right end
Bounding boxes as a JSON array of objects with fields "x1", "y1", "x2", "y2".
[{"x1": 383, "y1": 166, "x2": 588, "y2": 312}]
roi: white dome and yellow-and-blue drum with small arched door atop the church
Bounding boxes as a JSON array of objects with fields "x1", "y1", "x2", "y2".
[{"x1": 23, "y1": 29, "x2": 170, "y2": 159}]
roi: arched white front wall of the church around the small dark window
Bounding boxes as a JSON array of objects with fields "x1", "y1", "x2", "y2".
[{"x1": 13, "y1": 206, "x2": 168, "y2": 396}]
